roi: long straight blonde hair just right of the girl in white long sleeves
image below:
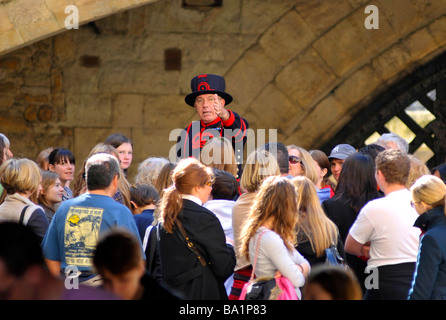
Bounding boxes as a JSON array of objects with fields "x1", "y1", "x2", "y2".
[{"x1": 292, "y1": 176, "x2": 345, "y2": 266}]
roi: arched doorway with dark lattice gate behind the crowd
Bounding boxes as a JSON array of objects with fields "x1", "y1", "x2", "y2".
[{"x1": 322, "y1": 53, "x2": 446, "y2": 168}]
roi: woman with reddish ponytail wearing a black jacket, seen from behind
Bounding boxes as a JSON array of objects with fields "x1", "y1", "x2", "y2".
[{"x1": 158, "y1": 158, "x2": 235, "y2": 300}]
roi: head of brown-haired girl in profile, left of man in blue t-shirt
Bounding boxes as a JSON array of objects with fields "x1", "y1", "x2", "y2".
[{"x1": 37, "y1": 170, "x2": 63, "y2": 223}]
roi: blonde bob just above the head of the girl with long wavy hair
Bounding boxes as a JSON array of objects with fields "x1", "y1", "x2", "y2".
[{"x1": 240, "y1": 149, "x2": 280, "y2": 192}]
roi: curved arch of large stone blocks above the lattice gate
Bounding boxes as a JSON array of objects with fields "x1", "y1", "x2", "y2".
[{"x1": 226, "y1": 0, "x2": 446, "y2": 148}]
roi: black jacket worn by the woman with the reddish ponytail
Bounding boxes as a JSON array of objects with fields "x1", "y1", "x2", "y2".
[{"x1": 159, "y1": 199, "x2": 236, "y2": 300}]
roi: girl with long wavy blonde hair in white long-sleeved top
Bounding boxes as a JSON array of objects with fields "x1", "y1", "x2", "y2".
[{"x1": 241, "y1": 176, "x2": 310, "y2": 299}]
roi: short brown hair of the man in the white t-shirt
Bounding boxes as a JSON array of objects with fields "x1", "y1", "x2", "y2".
[{"x1": 375, "y1": 149, "x2": 410, "y2": 186}]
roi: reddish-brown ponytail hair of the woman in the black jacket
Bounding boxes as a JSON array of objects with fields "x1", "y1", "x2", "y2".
[{"x1": 160, "y1": 158, "x2": 213, "y2": 233}]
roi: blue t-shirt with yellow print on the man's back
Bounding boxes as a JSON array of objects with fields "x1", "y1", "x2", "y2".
[{"x1": 42, "y1": 193, "x2": 140, "y2": 271}]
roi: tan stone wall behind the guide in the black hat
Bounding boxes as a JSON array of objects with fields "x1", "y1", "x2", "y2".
[{"x1": 0, "y1": 0, "x2": 446, "y2": 180}]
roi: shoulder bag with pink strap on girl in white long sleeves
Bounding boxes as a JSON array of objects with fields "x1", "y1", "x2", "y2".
[{"x1": 239, "y1": 230, "x2": 299, "y2": 300}]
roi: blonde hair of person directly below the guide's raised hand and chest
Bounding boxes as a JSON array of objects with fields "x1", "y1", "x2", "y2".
[{"x1": 200, "y1": 137, "x2": 238, "y2": 178}]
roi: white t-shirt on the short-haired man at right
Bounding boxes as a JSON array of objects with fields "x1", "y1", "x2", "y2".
[{"x1": 350, "y1": 189, "x2": 420, "y2": 267}]
